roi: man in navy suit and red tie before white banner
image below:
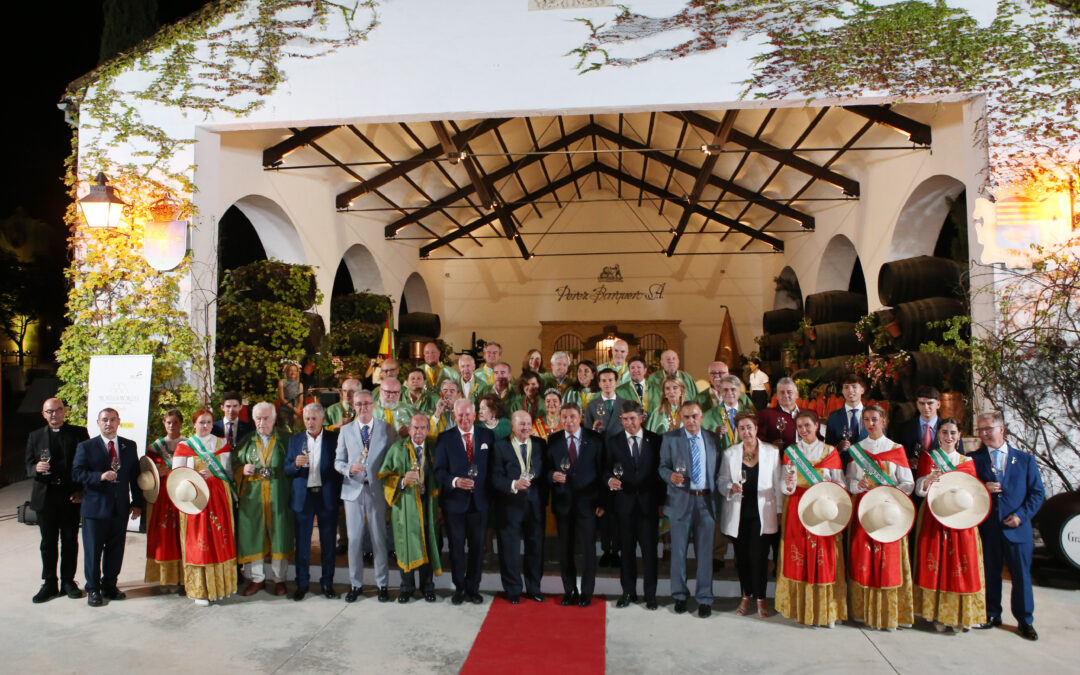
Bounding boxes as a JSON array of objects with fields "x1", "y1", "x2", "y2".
[{"x1": 71, "y1": 408, "x2": 143, "y2": 607}]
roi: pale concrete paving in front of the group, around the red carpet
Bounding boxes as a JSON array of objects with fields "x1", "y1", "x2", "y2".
[{"x1": 0, "y1": 482, "x2": 1080, "y2": 675}]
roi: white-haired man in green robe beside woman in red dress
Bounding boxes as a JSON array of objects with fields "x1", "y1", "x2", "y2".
[{"x1": 232, "y1": 401, "x2": 296, "y2": 595}]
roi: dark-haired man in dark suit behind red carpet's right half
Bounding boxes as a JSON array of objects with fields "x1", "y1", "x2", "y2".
[{"x1": 546, "y1": 403, "x2": 604, "y2": 607}]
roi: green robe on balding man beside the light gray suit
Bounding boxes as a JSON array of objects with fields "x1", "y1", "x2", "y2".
[{"x1": 379, "y1": 438, "x2": 443, "y2": 575}]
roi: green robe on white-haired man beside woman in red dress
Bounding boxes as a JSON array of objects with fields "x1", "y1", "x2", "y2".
[{"x1": 232, "y1": 432, "x2": 296, "y2": 563}]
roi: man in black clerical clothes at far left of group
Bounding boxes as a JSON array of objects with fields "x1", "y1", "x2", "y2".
[{"x1": 26, "y1": 399, "x2": 89, "y2": 603}]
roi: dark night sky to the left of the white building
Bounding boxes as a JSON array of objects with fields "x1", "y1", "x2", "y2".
[{"x1": 0, "y1": 0, "x2": 206, "y2": 226}]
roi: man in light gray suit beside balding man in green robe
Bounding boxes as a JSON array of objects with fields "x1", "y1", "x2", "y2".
[{"x1": 334, "y1": 389, "x2": 397, "y2": 603}]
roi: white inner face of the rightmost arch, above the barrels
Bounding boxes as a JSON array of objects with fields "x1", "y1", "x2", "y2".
[{"x1": 888, "y1": 175, "x2": 964, "y2": 262}]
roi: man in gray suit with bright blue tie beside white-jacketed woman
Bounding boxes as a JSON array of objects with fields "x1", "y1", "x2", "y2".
[{"x1": 660, "y1": 401, "x2": 717, "y2": 619}]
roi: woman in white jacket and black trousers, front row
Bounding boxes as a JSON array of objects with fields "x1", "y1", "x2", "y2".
[{"x1": 716, "y1": 411, "x2": 795, "y2": 617}]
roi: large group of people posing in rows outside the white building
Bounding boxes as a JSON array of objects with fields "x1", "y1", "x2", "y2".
[{"x1": 27, "y1": 340, "x2": 1043, "y2": 639}]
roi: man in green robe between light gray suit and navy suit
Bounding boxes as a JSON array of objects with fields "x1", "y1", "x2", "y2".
[{"x1": 379, "y1": 413, "x2": 443, "y2": 604}]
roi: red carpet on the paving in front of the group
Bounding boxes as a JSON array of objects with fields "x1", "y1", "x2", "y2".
[{"x1": 461, "y1": 593, "x2": 605, "y2": 675}]
